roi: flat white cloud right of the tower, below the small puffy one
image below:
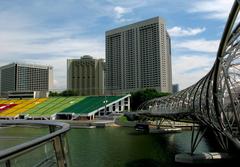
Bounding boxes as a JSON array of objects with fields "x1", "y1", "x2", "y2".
[{"x1": 173, "y1": 39, "x2": 220, "y2": 53}]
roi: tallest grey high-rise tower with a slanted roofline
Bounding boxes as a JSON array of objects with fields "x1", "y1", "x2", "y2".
[{"x1": 106, "y1": 17, "x2": 172, "y2": 94}]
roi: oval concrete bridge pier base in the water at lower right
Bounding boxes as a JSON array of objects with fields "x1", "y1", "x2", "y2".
[{"x1": 175, "y1": 152, "x2": 231, "y2": 164}]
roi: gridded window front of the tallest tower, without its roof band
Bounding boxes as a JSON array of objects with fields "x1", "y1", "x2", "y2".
[{"x1": 106, "y1": 23, "x2": 170, "y2": 89}]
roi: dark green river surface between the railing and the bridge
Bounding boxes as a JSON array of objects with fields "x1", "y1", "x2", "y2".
[{"x1": 0, "y1": 127, "x2": 223, "y2": 167}]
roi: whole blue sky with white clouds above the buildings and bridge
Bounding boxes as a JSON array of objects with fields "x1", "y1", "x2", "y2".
[{"x1": 0, "y1": 0, "x2": 234, "y2": 90}]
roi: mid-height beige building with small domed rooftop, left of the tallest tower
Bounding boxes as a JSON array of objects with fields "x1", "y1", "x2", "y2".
[{"x1": 67, "y1": 55, "x2": 104, "y2": 96}]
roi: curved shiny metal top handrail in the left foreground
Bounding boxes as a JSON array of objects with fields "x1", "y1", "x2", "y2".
[{"x1": 0, "y1": 120, "x2": 70, "y2": 166}]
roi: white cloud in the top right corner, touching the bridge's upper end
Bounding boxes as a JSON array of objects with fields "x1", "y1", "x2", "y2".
[{"x1": 189, "y1": 0, "x2": 234, "y2": 19}]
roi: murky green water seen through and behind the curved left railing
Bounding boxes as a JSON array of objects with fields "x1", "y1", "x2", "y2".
[{"x1": 0, "y1": 126, "x2": 56, "y2": 167}]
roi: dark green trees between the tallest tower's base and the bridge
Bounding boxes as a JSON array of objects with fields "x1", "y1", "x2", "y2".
[{"x1": 131, "y1": 89, "x2": 170, "y2": 111}]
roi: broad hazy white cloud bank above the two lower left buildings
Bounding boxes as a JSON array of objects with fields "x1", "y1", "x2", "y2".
[{"x1": 0, "y1": 15, "x2": 105, "y2": 90}]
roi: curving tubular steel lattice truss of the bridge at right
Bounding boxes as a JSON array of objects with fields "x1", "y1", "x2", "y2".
[{"x1": 140, "y1": 0, "x2": 240, "y2": 151}]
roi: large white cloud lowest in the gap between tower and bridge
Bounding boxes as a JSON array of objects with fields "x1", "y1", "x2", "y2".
[{"x1": 172, "y1": 55, "x2": 215, "y2": 89}]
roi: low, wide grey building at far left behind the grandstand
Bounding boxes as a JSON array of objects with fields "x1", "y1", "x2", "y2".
[{"x1": 0, "y1": 63, "x2": 53, "y2": 97}]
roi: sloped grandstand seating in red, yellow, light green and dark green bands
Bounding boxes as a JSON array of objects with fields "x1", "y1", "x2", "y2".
[{"x1": 0, "y1": 96, "x2": 127, "y2": 119}]
